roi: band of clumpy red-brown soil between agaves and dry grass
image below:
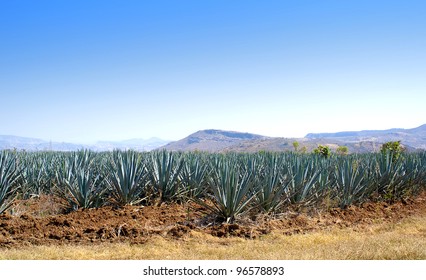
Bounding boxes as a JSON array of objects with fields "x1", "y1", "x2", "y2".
[{"x1": 0, "y1": 192, "x2": 426, "y2": 247}]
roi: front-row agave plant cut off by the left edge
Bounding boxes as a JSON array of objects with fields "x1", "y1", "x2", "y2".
[{"x1": 0, "y1": 151, "x2": 21, "y2": 213}]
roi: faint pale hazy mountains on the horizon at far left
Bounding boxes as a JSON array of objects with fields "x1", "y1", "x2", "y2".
[{"x1": 0, "y1": 135, "x2": 170, "y2": 151}]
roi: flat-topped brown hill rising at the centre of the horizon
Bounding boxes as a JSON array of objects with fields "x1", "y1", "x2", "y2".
[{"x1": 161, "y1": 129, "x2": 269, "y2": 152}]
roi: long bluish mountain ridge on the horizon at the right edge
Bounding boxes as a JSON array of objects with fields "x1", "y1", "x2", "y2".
[{"x1": 305, "y1": 124, "x2": 426, "y2": 149}]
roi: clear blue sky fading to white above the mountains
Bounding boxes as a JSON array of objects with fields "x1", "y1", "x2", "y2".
[{"x1": 0, "y1": 0, "x2": 426, "y2": 143}]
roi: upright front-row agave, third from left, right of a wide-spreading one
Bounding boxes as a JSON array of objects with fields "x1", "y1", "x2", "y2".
[{"x1": 106, "y1": 151, "x2": 148, "y2": 206}]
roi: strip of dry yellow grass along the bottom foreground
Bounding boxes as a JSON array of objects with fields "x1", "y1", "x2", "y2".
[{"x1": 0, "y1": 216, "x2": 426, "y2": 260}]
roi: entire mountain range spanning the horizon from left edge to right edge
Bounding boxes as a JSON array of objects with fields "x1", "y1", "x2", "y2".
[{"x1": 0, "y1": 124, "x2": 426, "y2": 153}]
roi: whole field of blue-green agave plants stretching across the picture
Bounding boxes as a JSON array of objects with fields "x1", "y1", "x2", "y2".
[{"x1": 0, "y1": 150, "x2": 426, "y2": 222}]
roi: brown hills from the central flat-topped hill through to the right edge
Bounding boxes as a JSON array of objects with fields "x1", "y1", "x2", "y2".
[{"x1": 161, "y1": 125, "x2": 426, "y2": 153}]
